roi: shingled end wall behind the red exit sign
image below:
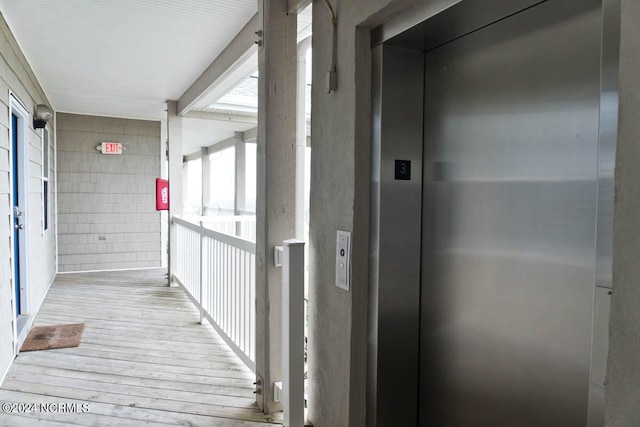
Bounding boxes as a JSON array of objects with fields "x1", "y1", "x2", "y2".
[{"x1": 57, "y1": 113, "x2": 162, "y2": 272}]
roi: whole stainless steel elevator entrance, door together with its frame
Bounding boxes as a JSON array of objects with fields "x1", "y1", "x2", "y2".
[{"x1": 367, "y1": 0, "x2": 620, "y2": 427}]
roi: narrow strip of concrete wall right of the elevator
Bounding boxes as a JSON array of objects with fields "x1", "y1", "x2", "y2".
[{"x1": 606, "y1": 0, "x2": 640, "y2": 427}]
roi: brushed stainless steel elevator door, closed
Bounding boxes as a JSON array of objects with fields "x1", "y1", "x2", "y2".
[{"x1": 419, "y1": 0, "x2": 601, "y2": 427}]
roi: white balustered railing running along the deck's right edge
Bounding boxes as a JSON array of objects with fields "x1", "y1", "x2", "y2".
[{"x1": 173, "y1": 217, "x2": 256, "y2": 371}]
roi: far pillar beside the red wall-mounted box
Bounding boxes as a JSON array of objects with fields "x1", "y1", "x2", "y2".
[{"x1": 167, "y1": 101, "x2": 183, "y2": 280}]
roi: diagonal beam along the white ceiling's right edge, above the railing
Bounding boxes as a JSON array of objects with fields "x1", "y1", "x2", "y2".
[{"x1": 178, "y1": 13, "x2": 262, "y2": 116}]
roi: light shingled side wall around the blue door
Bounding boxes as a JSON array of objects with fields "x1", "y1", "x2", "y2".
[{"x1": 0, "y1": 12, "x2": 56, "y2": 380}]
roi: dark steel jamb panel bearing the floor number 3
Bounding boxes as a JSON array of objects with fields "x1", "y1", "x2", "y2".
[{"x1": 367, "y1": 46, "x2": 424, "y2": 427}]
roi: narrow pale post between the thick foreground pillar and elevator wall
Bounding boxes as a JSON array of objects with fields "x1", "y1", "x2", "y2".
[{"x1": 295, "y1": 36, "x2": 311, "y2": 240}]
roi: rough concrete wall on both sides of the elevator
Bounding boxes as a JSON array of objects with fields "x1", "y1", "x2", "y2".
[{"x1": 309, "y1": 0, "x2": 640, "y2": 426}]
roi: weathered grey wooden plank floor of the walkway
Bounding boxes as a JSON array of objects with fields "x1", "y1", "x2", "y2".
[{"x1": 0, "y1": 270, "x2": 278, "y2": 427}]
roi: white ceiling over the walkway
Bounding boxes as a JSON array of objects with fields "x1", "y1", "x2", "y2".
[{"x1": 0, "y1": 0, "x2": 257, "y2": 120}]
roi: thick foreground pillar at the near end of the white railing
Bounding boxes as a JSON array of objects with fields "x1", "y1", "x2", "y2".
[{"x1": 256, "y1": 0, "x2": 297, "y2": 413}]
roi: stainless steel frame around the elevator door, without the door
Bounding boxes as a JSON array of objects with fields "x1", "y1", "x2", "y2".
[{"x1": 367, "y1": 0, "x2": 620, "y2": 427}]
